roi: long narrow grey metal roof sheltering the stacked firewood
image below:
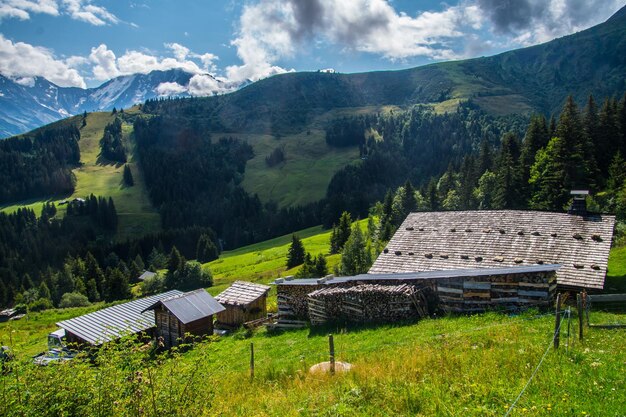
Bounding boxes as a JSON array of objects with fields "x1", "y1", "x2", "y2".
[{"x1": 275, "y1": 264, "x2": 561, "y2": 285}]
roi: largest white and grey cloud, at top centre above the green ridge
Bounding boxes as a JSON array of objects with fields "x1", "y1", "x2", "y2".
[{"x1": 227, "y1": 0, "x2": 483, "y2": 80}]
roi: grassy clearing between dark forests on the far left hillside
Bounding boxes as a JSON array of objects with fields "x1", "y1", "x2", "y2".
[{"x1": 2, "y1": 112, "x2": 160, "y2": 239}]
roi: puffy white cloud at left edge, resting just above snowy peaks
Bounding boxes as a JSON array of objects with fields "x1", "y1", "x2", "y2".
[{"x1": 0, "y1": 34, "x2": 85, "y2": 88}]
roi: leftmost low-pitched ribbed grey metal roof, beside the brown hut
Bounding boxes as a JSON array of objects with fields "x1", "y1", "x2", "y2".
[{"x1": 57, "y1": 290, "x2": 182, "y2": 345}]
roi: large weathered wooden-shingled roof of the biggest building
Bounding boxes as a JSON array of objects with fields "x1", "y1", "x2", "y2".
[{"x1": 369, "y1": 210, "x2": 615, "y2": 288}]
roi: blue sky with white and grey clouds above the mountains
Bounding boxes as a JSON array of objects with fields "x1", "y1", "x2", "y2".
[{"x1": 0, "y1": 0, "x2": 625, "y2": 91}]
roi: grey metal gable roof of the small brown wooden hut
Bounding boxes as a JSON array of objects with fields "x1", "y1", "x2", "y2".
[{"x1": 144, "y1": 288, "x2": 226, "y2": 324}]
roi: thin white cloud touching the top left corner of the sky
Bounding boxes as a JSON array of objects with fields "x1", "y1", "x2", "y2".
[{"x1": 0, "y1": 0, "x2": 120, "y2": 26}]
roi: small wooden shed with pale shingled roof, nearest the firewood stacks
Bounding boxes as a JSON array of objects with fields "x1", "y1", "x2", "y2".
[{"x1": 215, "y1": 281, "x2": 271, "y2": 328}]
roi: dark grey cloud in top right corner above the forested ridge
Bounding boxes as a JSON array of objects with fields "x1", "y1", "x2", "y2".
[{"x1": 477, "y1": 0, "x2": 624, "y2": 45}]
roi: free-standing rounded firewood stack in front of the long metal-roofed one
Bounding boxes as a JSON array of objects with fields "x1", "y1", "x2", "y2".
[{"x1": 308, "y1": 284, "x2": 428, "y2": 325}]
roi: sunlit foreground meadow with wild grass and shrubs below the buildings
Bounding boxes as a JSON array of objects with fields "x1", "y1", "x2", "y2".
[{"x1": 0, "y1": 313, "x2": 626, "y2": 416}]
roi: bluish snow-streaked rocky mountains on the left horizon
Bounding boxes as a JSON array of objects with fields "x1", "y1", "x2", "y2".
[{"x1": 0, "y1": 69, "x2": 194, "y2": 137}]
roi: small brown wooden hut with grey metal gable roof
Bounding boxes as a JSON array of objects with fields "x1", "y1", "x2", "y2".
[{"x1": 144, "y1": 288, "x2": 224, "y2": 348}]
